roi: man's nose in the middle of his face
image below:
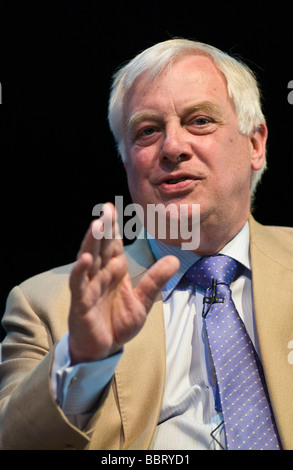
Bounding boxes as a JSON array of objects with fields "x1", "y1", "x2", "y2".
[{"x1": 161, "y1": 123, "x2": 192, "y2": 163}]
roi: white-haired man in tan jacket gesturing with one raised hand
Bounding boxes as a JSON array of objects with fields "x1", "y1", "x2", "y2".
[{"x1": 0, "y1": 39, "x2": 293, "y2": 450}]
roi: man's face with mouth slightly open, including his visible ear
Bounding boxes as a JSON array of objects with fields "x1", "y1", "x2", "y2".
[{"x1": 124, "y1": 56, "x2": 264, "y2": 250}]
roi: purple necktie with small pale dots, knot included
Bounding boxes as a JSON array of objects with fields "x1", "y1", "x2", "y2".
[{"x1": 186, "y1": 255, "x2": 280, "y2": 450}]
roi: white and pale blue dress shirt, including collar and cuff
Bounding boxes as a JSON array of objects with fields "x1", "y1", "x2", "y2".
[{"x1": 52, "y1": 222, "x2": 258, "y2": 450}]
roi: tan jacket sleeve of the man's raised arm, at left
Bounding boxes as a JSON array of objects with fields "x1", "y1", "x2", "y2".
[{"x1": 0, "y1": 276, "x2": 91, "y2": 450}]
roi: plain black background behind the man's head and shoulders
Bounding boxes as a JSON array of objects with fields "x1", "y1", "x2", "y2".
[{"x1": 0, "y1": 0, "x2": 293, "y2": 338}]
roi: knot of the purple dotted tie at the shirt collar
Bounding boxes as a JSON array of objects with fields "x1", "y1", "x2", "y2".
[{"x1": 186, "y1": 255, "x2": 240, "y2": 289}]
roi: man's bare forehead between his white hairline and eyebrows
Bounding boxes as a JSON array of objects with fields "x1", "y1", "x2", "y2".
[{"x1": 124, "y1": 55, "x2": 231, "y2": 117}]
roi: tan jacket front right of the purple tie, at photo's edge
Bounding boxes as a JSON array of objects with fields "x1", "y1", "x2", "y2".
[{"x1": 250, "y1": 218, "x2": 293, "y2": 449}]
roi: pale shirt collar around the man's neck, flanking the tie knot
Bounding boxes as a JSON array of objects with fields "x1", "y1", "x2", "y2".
[{"x1": 146, "y1": 222, "x2": 250, "y2": 300}]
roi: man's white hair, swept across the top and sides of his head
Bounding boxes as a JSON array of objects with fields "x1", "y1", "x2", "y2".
[{"x1": 108, "y1": 39, "x2": 266, "y2": 194}]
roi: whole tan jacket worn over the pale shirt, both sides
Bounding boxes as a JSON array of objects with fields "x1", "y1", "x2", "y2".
[{"x1": 0, "y1": 217, "x2": 293, "y2": 450}]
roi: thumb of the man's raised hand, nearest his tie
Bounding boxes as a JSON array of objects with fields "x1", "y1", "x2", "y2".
[{"x1": 135, "y1": 255, "x2": 180, "y2": 311}]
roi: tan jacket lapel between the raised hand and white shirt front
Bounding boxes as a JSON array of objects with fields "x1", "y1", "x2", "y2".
[{"x1": 115, "y1": 239, "x2": 166, "y2": 449}]
